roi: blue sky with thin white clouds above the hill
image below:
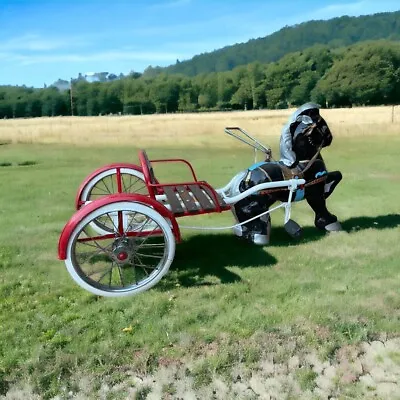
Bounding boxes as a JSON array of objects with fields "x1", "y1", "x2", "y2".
[{"x1": 0, "y1": 0, "x2": 400, "y2": 87}]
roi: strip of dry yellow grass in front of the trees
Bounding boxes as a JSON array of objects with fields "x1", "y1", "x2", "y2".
[{"x1": 0, "y1": 106, "x2": 400, "y2": 147}]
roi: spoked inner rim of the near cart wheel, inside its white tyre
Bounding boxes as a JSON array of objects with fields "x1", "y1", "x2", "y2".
[{"x1": 71, "y1": 207, "x2": 169, "y2": 293}]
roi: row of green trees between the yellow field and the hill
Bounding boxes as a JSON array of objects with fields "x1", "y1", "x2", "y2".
[{"x1": 0, "y1": 40, "x2": 400, "y2": 118}]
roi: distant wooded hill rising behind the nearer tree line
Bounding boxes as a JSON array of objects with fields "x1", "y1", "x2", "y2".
[{"x1": 144, "y1": 11, "x2": 400, "y2": 76}]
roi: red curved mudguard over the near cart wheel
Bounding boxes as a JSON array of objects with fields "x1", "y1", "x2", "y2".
[{"x1": 58, "y1": 193, "x2": 181, "y2": 260}]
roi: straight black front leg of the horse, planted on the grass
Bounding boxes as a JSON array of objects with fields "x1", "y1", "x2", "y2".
[{"x1": 306, "y1": 184, "x2": 342, "y2": 232}]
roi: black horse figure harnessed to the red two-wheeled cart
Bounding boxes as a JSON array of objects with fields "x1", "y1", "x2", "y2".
[{"x1": 233, "y1": 114, "x2": 342, "y2": 245}]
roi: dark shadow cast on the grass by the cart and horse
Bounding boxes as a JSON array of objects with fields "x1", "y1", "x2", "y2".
[{"x1": 160, "y1": 214, "x2": 400, "y2": 290}]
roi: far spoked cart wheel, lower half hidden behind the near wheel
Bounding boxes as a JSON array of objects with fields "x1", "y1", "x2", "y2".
[{"x1": 79, "y1": 167, "x2": 148, "y2": 205}]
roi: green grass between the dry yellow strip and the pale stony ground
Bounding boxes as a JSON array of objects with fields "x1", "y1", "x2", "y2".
[{"x1": 0, "y1": 137, "x2": 400, "y2": 398}]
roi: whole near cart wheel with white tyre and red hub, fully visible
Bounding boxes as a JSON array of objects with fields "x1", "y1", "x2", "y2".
[{"x1": 65, "y1": 201, "x2": 175, "y2": 297}]
